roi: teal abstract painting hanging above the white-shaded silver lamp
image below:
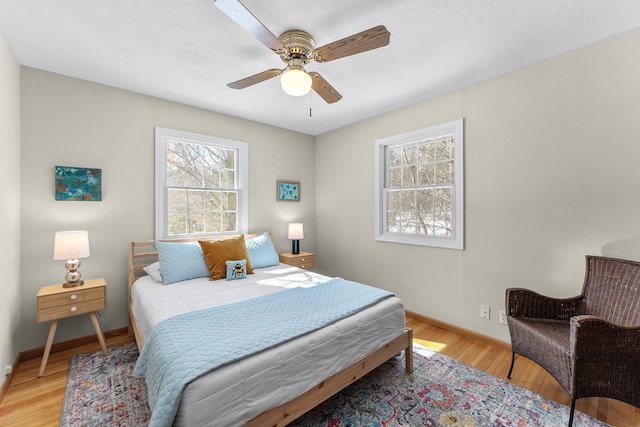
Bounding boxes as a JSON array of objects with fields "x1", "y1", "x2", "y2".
[{"x1": 55, "y1": 166, "x2": 102, "y2": 202}]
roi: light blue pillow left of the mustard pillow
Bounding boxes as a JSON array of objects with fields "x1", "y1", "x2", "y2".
[{"x1": 156, "y1": 242, "x2": 209, "y2": 285}]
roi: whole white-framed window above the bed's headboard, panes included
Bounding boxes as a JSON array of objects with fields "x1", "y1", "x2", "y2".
[{"x1": 156, "y1": 128, "x2": 248, "y2": 239}]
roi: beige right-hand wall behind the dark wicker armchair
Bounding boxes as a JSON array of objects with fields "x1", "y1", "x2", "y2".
[{"x1": 316, "y1": 27, "x2": 640, "y2": 341}]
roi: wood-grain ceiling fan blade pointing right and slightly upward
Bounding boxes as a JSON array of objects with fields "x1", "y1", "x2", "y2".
[{"x1": 313, "y1": 25, "x2": 391, "y2": 62}]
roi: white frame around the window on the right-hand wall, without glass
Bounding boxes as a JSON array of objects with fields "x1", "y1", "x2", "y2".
[{"x1": 375, "y1": 119, "x2": 464, "y2": 250}]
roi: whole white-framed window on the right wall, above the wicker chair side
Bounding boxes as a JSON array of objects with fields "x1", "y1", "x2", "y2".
[{"x1": 376, "y1": 119, "x2": 464, "y2": 249}]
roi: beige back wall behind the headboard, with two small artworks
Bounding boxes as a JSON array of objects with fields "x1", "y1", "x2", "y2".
[{"x1": 21, "y1": 68, "x2": 315, "y2": 350}]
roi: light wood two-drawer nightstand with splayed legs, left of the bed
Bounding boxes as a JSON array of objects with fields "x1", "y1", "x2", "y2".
[{"x1": 36, "y1": 279, "x2": 109, "y2": 378}]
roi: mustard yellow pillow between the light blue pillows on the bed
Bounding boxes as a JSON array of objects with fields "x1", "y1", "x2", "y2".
[{"x1": 198, "y1": 236, "x2": 253, "y2": 280}]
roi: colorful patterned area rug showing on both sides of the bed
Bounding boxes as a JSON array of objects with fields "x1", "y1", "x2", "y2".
[{"x1": 60, "y1": 343, "x2": 607, "y2": 427}]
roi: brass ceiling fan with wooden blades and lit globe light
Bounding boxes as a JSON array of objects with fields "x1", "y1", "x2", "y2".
[{"x1": 214, "y1": 0, "x2": 391, "y2": 104}]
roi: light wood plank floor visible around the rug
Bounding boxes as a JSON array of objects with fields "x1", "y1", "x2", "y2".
[{"x1": 0, "y1": 318, "x2": 640, "y2": 427}]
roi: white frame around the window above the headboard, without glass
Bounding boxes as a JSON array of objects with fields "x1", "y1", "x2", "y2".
[{"x1": 155, "y1": 127, "x2": 249, "y2": 240}]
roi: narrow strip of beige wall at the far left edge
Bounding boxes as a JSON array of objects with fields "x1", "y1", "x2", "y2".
[{"x1": 0, "y1": 31, "x2": 20, "y2": 384}]
